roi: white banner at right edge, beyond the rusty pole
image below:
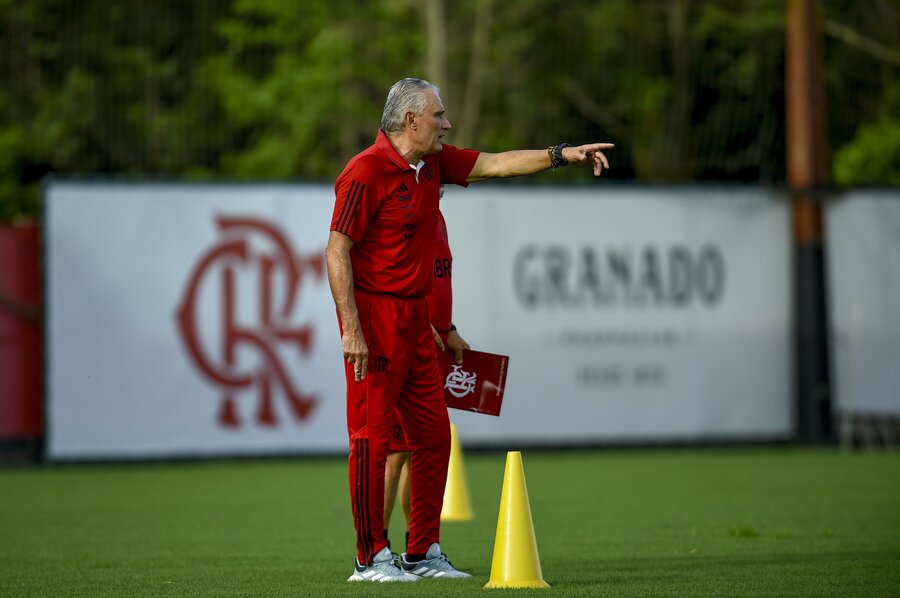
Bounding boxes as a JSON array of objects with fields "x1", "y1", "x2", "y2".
[{"x1": 826, "y1": 190, "x2": 900, "y2": 416}]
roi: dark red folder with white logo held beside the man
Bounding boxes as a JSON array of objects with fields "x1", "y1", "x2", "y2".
[{"x1": 440, "y1": 349, "x2": 509, "y2": 416}]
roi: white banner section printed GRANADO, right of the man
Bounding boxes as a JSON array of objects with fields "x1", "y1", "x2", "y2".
[{"x1": 443, "y1": 185, "x2": 792, "y2": 444}]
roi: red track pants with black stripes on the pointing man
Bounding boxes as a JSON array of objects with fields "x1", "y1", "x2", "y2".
[{"x1": 344, "y1": 290, "x2": 450, "y2": 564}]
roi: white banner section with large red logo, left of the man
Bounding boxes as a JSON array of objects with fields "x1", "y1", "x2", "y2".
[{"x1": 46, "y1": 184, "x2": 347, "y2": 458}]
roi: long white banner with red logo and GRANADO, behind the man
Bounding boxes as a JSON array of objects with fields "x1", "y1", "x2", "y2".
[{"x1": 46, "y1": 183, "x2": 791, "y2": 459}]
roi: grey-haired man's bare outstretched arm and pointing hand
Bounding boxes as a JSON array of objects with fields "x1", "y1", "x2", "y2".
[{"x1": 466, "y1": 143, "x2": 615, "y2": 183}]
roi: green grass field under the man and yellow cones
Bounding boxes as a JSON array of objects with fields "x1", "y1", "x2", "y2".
[{"x1": 0, "y1": 448, "x2": 900, "y2": 597}]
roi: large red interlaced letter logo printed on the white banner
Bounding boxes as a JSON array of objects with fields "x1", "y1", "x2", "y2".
[{"x1": 177, "y1": 216, "x2": 325, "y2": 428}]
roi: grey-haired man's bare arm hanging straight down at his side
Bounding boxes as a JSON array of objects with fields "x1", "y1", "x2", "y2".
[{"x1": 325, "y1": 231, "x2": 369, "y2": 381}]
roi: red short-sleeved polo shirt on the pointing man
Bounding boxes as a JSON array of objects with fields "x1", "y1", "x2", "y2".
[{"x1": 331, "y1": 131, "x2": 479, "y2": 297}]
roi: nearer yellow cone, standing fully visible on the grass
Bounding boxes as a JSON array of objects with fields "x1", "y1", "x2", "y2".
[{"x1": 484, "y1": 451, "x2": 550, "y2": 588}]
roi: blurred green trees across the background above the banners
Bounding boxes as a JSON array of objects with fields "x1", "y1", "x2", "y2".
[{"x1": 0, "y1": 0, "x2": 900, "y2": 220}]
